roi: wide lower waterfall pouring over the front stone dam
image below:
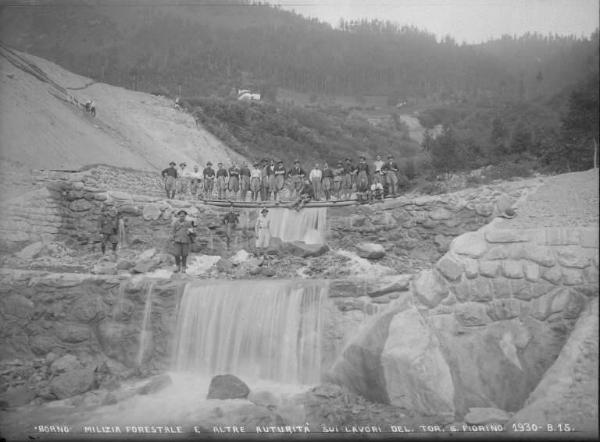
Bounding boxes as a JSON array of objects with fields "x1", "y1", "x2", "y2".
[{"x1": 174, "y1": 281, "x2": 328, "y2": 384}]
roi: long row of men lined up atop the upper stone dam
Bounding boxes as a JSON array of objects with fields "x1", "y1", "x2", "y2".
[{"x1": 161, "y1": 155, "x2": 400, "y2": 201}]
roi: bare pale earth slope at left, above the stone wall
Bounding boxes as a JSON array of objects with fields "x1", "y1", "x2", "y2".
[{"x1": 0, "y1": 47, "x2": 242, "y2": 176}]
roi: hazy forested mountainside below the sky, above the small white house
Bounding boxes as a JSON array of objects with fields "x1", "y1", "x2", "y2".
[{"x1": 0, "y1": 0, "x2": 597, "y2": 104}]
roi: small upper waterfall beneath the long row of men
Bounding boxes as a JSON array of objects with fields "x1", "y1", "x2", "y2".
[{"x1": 269, "y1": 207, "x2": 327, "y2": 244}]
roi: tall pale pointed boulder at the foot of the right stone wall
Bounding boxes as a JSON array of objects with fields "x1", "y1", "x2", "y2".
[{"x1": 381, "y1": 307, "x2": 455, "y2": 418}]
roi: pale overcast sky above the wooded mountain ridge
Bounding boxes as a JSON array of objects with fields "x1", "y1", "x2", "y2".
[{"x1": 271, "y1": 0, "x2": 600, "y2": 43}]
